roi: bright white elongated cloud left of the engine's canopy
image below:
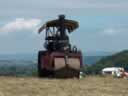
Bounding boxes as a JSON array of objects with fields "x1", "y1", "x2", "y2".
[{"x1": 0, "y1": 18, "x2": 41, "y2": 33}]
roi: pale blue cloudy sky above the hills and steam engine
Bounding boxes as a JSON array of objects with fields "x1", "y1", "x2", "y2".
[{"x1": 0, "y1": 0, "x2": 128, "y2": 54}]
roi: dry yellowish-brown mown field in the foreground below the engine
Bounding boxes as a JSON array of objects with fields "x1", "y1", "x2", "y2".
[{"x1": 0, "y1": 76, "x2": 128, "y2": 96}]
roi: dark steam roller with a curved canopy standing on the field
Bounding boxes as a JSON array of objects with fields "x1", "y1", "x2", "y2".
[{"x1": 38, "y1": 15, "x2": 82, "y2": 78}]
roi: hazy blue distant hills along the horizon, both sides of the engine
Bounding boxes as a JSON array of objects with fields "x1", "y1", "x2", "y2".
[{"x1": 0, "y1": 51, "x2": 112, "y2": 65}]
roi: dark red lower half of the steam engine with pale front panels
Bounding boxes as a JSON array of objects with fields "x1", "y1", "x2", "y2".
[{"x1": 38, "y1": 51, "x2": 81, "y2": 78}]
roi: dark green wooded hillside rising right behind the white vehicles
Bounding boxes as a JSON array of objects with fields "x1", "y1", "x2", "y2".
[{"x1": 84, "y1": 50, "x2": 128, "y2": 74}]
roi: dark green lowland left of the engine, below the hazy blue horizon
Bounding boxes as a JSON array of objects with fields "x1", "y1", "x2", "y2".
[{"x1": 0, "y1": 60, "x2": 37, "y2": 76}]
